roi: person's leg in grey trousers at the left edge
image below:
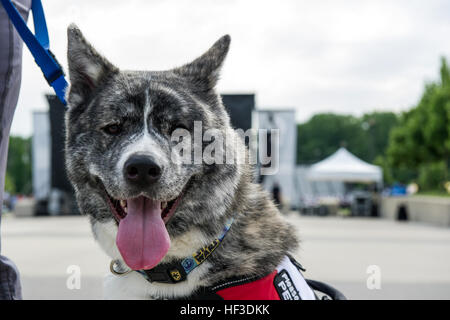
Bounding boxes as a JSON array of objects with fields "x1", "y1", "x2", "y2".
[{"x1": 0, "y1": 0, "x2": 31, "y2": 300}]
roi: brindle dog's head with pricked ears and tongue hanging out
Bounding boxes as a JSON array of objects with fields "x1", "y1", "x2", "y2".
[{"x1": 66, "y1": 25, "x2": 241, "y2": 269}]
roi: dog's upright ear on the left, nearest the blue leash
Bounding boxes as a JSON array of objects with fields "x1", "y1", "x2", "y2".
[{"x1": 67, "y1": 24, "x2": 118, "y2": 106}]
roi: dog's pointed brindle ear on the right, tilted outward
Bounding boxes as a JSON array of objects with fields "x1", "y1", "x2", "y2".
[{"x1": 173, "y1": 35, "x2": 231, "y2": 92}]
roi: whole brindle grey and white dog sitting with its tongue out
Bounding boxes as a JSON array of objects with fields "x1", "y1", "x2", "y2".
[{"x1": 65, "y1": 24, "x2": 312, "y2": 299}]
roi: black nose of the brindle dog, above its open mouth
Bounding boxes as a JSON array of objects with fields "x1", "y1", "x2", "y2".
[{"x1": 124, "y1": 155, "x2": 162, "y2": 185}]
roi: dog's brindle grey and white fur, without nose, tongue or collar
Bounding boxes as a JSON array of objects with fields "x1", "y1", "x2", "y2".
[{"x1": 66, "y1": 25, "x2": 298, "y2": 298}]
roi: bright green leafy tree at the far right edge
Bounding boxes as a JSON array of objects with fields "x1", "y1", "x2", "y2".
[{"x1": 386, "y1": 58, "x2": 450, "y2": 190}]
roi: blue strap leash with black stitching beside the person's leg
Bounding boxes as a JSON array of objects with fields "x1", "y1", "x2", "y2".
[{"x1": 0, "y1": 0, "x2": 68, "y2": 105}]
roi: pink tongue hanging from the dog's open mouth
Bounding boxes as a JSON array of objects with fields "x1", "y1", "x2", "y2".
[{"x1": 116, "y1": 196, "x2": 170, "y2": 270}]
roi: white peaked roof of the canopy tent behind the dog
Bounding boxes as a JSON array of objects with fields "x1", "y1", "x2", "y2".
[{"x1": 308, "y1": 148, "x2": 383, "y2": 184}]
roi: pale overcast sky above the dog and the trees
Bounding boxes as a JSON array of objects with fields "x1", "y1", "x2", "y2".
[{"x1": 12, "y1": 0, "x2": 450, "y2": 136}]
